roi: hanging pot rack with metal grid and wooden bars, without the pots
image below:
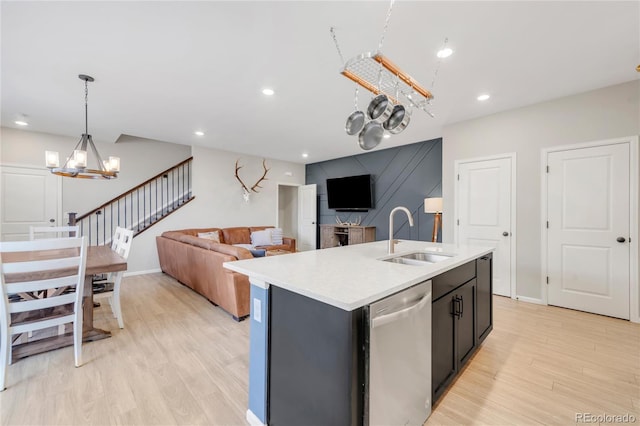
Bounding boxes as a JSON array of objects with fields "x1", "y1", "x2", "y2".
[{"x1": 340, "y1": 52, "x2": 433, "y2": 117}]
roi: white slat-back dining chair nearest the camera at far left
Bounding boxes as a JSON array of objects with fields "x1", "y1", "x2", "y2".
[{"x1": 0, "y1": 237, "x2": 87, "y2": 390}]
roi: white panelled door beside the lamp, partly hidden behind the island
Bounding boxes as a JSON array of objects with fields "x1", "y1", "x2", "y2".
[{"x1": 456, "y1": 157, "x2": 515, "y2": 297}]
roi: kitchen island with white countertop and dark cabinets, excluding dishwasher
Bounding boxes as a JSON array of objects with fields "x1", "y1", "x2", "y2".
[{"x1": 225, "y1": 241, "x2": 492, "y2": 425}]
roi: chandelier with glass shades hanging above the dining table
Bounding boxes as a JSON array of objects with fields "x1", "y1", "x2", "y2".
[{"x1": 45, "y1": 74, "x2": 120, "y2": 179}]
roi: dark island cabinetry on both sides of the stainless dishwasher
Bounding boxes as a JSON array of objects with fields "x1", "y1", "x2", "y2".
[{"x1": 267, "y1": 254, "x2": 493, "y2": 426}]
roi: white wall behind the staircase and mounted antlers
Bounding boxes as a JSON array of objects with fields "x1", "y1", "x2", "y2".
[{"x1": 0, "y1": 127, "x2": 304, "y2": 273}]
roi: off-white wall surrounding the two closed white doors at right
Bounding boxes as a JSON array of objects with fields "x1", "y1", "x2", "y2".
[{"x1": 442, "y1": 80, "x2": 640, "y2": 299}]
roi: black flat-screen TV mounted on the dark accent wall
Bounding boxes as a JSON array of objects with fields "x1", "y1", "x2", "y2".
[{"x1": 327, "y1": 175, "x2": 373, "y2": 211}]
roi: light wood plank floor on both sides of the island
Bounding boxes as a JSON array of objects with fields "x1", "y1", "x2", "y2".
[{"x1": 0, "y1": 274, "x2": 640, "y2": 425}]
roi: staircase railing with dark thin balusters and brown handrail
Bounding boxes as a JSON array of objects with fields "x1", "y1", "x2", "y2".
[{"x1": 69, "y1": 157, "x2": 195, "y2": 246}]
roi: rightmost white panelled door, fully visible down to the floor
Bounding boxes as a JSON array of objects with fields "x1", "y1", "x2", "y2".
[{"x1": 547, "y1": 143, "x2": 630, "y2": 319}]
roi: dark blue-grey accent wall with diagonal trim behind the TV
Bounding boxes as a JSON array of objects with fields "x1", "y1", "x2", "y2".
[{"x1": 306, "y1": 138, "x2": 442, "y2": 246}]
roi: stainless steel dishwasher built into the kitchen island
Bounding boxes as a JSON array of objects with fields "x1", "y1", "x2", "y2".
[{"x1": 365, "y1": 281, "x2": 431, "y2": 426}]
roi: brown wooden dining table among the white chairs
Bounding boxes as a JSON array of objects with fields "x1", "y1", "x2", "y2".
[{"x1": 2, "y1": 245, "x2": 127, "y2": 361}]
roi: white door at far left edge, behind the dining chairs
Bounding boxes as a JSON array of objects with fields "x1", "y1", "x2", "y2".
[{"x1": 0, "y1": 166, "x2": 63, "y2": 241}]
